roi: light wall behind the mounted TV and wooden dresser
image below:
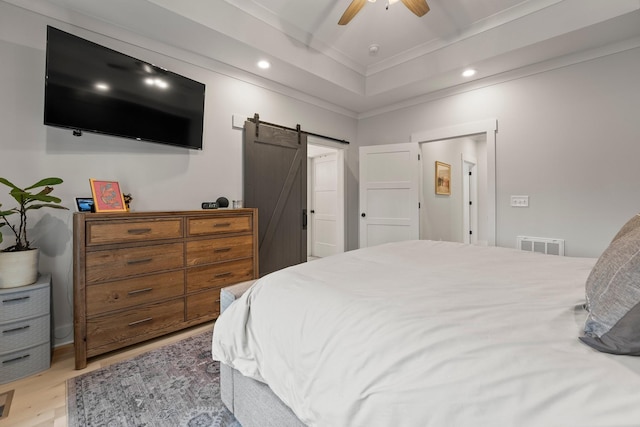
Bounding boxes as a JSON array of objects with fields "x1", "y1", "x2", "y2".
[{"x1": 0, "y1": 0, "x2": 357, "y2": 344}]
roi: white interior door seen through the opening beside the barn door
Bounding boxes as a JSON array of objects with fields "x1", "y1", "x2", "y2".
[{"x1": 311, "y1": 153, "x2": 338, "y2": 257}]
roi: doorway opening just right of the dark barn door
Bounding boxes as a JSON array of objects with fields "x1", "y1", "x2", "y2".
[{"x1": 307, "y1": 140, "x2": 345, "y2": 260}]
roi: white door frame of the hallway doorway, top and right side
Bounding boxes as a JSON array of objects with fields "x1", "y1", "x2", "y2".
[{"x1": 411, "y1": 119, "x2": 498, "y2": 246}]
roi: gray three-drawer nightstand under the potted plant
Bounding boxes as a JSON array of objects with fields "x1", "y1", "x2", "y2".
[{"x1": 0, "y1": 274, "x2": 51, "y2": 384}]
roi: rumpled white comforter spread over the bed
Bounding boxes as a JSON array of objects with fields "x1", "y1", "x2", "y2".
[{"x1": 213, "y1": 241, "x2": 640, "y2": 427}]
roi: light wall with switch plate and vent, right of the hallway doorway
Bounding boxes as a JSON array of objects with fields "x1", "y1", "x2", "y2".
[{"x1": 358, "y1": 44, "x2": 640, "y2": 257}]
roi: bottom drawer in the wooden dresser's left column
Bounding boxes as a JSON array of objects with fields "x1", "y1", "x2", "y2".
[{"x1": 87, "y1": 298, "x2": 184, "y2": 356}]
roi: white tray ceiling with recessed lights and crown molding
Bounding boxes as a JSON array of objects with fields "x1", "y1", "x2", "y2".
[{"x1": 31, "y1": 0, "x2": 640, "y2": 116}]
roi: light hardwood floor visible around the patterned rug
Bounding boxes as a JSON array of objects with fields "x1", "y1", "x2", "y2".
[{"x1": 0, "y1": 322, "x2": 213, "y2": 427}]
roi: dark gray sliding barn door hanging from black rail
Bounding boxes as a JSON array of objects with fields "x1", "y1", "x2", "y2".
[{"x1": 243, "y1": 121, "x2": 307, "y2": 276}]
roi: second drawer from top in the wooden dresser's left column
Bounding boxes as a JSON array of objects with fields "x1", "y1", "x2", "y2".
[{"x1": 86, "y1": 243, "x2": 184, "y2": 284}]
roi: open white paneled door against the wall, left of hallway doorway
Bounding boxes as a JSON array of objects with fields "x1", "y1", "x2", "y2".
[{"x1": 360, "y1": 142, "x2": 420, "y2": 248}]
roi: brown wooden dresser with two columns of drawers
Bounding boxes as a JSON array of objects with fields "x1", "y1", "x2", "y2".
[{"x1": 73, "y1": 209, "x2": 258, "y2": 369}]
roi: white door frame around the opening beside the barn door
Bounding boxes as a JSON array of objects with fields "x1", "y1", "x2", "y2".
[{"x1": 307, "y1": 139, "x2": 347, "y2": 255}]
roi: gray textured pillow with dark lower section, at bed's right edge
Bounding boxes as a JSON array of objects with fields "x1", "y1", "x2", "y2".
[{"x1": 580, "y1": 215, "x2": 640, "y2": 356}]
